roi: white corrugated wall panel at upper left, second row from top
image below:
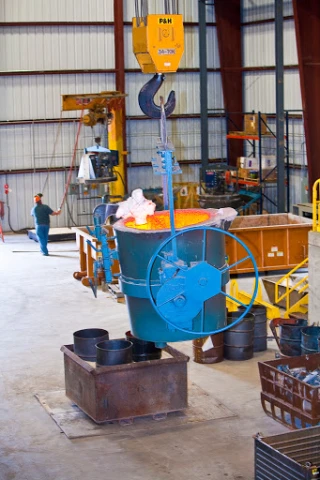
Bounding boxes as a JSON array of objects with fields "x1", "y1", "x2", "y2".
[{"x1": 0, "y1": 25, "x2": 114, "y2": 70}]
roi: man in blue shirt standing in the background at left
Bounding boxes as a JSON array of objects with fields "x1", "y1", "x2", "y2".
[{"x1": 31, "y1": 193, "x2": 61, "y2": 257}]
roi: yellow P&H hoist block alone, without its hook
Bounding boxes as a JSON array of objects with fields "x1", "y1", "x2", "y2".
[{"x1": 132, "y1": 15, "x2": 184, "y2": 73}]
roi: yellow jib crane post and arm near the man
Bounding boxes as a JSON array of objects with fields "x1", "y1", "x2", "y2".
[{"x1": 62, "y1": 91, "x2": 127, "y2": 197}]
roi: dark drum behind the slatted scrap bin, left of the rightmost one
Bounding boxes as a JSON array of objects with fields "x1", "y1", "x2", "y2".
[{"x1": 279, "y1": 318, "x2": 308, "y2": 357}]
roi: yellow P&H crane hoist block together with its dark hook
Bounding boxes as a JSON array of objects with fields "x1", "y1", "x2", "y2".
[{"x1": 132, "y1": 0, "x2": 184, "y2": 119}]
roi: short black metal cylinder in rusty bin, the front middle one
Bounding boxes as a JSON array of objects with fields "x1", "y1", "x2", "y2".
[{"x1": 96, "y1": 338, "x2": 132, "y2": 366}]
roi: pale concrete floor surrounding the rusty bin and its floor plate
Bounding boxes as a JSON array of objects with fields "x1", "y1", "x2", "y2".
[{"x1": 0, "y1": 235, "x2": 288, "y2": 480}]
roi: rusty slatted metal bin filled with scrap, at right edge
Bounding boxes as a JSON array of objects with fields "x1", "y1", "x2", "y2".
[{"x1": 258, "y1": 353, "x2": 320, "y2": 429}]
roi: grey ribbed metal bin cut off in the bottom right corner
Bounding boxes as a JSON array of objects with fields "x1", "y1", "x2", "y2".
[{"x1": 254, "y1": 427, "x2": 320, "y2": 480}]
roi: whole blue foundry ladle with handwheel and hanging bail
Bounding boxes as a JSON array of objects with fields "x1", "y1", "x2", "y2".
[{"x1": 86, "y1": 101, "x2": 258, "y2": 348}]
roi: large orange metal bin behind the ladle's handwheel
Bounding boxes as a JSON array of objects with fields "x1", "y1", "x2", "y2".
[{"x1": 226, "y1": 213, "x2": 312, "y2": 273}]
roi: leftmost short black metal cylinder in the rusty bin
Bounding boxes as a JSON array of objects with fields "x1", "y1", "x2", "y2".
[{"x1": 73, "y1": 328, "x2": 109, "y2": 362}]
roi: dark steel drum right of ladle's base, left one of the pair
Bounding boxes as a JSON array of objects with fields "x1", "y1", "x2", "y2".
[{"x1": 224, "y1": 312, "x2": 254, "y2": 360}]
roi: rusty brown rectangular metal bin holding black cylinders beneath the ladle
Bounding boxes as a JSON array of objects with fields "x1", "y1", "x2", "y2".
[{"x1": 61, "y1": 345, "x2": 189, "y2": 423}]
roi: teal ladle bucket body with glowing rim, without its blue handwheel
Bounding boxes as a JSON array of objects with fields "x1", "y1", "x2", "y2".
[{"x1": 113, "y1": 209, "x2": 230, "y2": 344}]
